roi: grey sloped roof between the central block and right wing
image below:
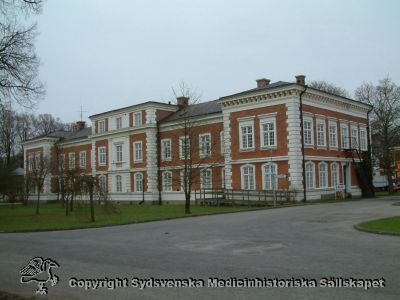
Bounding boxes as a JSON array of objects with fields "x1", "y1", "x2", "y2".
[{"x1": 161, "y1": 100, "x2": 222, "y2": 123}]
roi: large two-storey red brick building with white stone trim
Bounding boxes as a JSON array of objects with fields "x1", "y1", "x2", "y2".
[{"x1": 24, "y1": 75, "x2": 371, "y2": 201}]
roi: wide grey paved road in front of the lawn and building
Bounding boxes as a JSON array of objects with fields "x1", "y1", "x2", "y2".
[{"x1": 0, "y1": 197, "x2": 400, "y2": 299}]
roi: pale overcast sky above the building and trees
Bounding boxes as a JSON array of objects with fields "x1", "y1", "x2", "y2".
[{"x1": 32, "y1": 0, "x2": 400, "y2": 122}]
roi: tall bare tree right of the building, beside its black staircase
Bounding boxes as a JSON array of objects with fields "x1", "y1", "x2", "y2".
[{"x1": 355, "y1": 77, "x2": 400, "y2": 191}]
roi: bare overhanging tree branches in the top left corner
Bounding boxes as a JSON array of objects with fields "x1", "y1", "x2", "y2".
[{"x1": 0, "y1": 0, "x2": 45, "y2": 107}]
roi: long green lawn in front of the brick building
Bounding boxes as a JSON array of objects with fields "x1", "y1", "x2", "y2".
[{"x1": 0, "y1": 203, "x2": 274, "y2": 232}]
